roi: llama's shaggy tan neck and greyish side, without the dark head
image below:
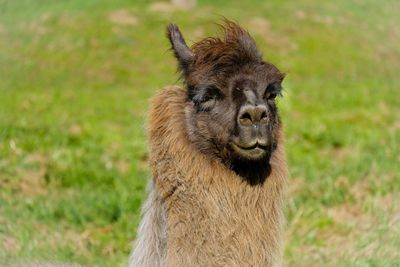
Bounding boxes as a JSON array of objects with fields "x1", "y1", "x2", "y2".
[{"x1": 129, "y1": 87, "x2": 287, "y2": 267}]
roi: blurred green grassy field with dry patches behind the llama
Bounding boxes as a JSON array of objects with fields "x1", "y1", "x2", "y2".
[{"x1": 0, "y1": 0, "x2": 400, "y2": 266}]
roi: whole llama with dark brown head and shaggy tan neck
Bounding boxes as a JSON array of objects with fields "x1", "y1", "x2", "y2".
[{"x1": 129, "y1": 21, "x2": 287, "y2": 267}]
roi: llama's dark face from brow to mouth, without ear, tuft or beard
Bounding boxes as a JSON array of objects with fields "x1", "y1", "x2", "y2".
[{"x1": 187, "y1": 62, "x2": 282, "y2": 160}]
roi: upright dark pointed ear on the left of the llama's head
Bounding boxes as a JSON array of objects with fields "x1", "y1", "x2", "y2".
[{"x1": 167, "y1": 23, "x2": 193, "y2": 77}]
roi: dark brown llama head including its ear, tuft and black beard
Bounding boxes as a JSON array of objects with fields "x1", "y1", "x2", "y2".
[{"x1": 167, "y1": 21, "x2": 284, "y2": 185}]
